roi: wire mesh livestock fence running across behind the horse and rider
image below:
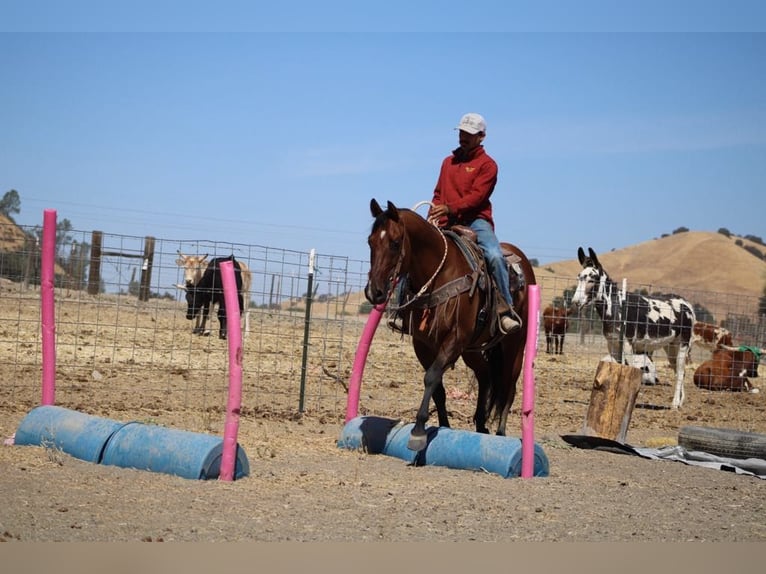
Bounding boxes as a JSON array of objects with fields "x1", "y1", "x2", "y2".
[{"x1": 0, "y1": 224, "x2": 766, "y2": 432}]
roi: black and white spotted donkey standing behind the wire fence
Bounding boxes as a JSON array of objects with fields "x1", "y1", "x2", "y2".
[{"x1": 572, "y1": 247, "x2": 696, "y2": 409}]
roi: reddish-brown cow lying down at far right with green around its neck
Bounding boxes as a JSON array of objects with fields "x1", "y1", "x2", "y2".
[{"x1": 694, "y1": 347, "x2": 760, "y2": 393}]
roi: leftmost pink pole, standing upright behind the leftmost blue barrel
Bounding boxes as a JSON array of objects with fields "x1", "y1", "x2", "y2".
[{"x1": 40, "y1": 209, "x2": 56, "y2": 405}]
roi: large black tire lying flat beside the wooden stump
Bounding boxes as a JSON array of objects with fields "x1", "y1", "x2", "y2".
[{"x1": 678, "y1": 426, "x2": 766, "y2": 460}]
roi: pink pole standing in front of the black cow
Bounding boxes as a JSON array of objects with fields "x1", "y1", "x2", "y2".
[{"x1": 218, "y1": 261, "x2": 243, "y2": 482}]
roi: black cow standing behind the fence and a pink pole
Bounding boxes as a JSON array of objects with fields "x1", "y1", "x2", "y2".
[{"x1": 186, "y1": 255, "x2": 244, "y2": 339}]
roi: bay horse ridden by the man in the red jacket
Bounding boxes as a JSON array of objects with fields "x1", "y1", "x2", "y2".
[{"x1": 364, "y1": 199, "x2": 536, "y2": 452}]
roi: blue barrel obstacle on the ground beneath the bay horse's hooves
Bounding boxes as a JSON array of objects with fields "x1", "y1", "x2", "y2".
[{"x1": 338, "y1": 417, "x2": 549, "y2": 478}]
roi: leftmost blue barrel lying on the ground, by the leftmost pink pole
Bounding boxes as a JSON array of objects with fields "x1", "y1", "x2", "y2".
[{"x1": 14, "y1": 405, "x2": 132, "y2": 463}]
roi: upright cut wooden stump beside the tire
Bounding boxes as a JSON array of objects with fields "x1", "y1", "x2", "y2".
[{"x1": 583, "y1": 361, "x2": 641, "y2": 443}]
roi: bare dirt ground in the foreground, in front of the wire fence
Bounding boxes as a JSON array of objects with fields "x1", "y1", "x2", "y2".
[{"x1": 0, "y1": 415, "x2": 766, "y2": 542}]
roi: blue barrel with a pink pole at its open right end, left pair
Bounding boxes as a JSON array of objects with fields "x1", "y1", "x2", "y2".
[{"x1": 101, "y1": 423, "x2": 250, "y2": 479}]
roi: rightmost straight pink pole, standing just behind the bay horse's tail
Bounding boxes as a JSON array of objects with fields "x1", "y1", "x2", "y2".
[{"x1": 521, "y1": 285, "x2": 540, "y2": 478}]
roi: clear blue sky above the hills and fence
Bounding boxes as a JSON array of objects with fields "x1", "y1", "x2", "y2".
[{"x1": 0, "y1": 0, "x2": 766, "y2": 263}]
